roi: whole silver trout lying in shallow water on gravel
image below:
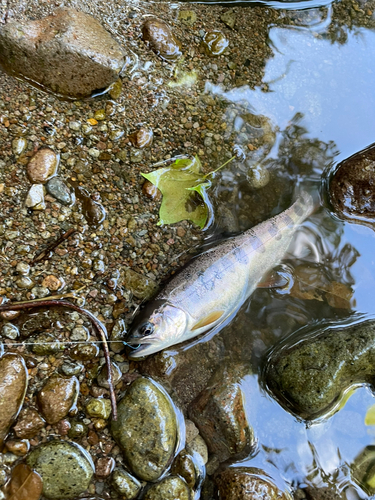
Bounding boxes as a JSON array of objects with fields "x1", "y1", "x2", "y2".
[{"x1": 128, "y1": 192, "x2": 314, "y2": 358}]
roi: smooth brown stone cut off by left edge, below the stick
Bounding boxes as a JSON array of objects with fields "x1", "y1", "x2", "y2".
[{"x1": 0, "y1": 354, "x2": 28, "y2": 446}]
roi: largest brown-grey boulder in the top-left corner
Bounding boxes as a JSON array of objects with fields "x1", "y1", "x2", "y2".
[{"x1": 0, "y1": 8, "x2": 125, "y2": 98}]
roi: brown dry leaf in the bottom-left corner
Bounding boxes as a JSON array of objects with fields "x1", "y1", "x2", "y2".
[{"x1": 4, "y1": 464, "x2": 43, "y2": 500}]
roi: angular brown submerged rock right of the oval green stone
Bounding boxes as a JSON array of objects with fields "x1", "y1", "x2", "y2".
[{"x1": 189, "y1": 365, "x2": 254, "y2": 461}]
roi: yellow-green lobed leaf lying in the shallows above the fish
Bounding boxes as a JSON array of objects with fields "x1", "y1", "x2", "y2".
[{"x1": 142, "y1": 156, "x2": 211, "y2": 229}]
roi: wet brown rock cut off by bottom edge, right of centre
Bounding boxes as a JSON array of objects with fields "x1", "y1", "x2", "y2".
[{"x1": 215, "y1": 467, "x2": 291, "y2": 500}]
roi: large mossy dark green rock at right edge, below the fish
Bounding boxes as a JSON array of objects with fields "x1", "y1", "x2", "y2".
[{"x1": 264, "y1": 320, "x2": 375, "y2": 420}]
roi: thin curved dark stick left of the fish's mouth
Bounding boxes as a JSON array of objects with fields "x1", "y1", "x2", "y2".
[{"x1": 0, "y1": 299, "x2": 117, "y2": 420}]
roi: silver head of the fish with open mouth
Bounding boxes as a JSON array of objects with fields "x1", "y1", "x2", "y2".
[{"x1": 127, "y1": 301, "x2": 188, "y2": 359}]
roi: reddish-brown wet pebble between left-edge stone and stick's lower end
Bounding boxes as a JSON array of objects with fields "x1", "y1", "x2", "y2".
[{"x1": 37, "y1": 375, "x2": 79, "y2": 424}]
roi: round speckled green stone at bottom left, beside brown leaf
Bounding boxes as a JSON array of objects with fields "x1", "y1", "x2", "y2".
[{"x1": 26, "y1": 440, "x2": 94, "y2": 500}]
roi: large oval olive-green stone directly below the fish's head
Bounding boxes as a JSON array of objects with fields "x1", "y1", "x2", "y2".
[{"x1": 111, "y1": 377, "x2": 177, "y2": 481}]
